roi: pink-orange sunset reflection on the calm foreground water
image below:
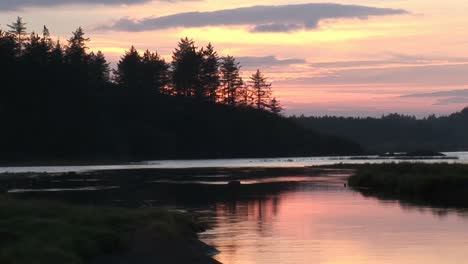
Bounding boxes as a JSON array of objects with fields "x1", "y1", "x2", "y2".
[{"x1": 202, "y1": 186, "x2": 468, "y2": 264}]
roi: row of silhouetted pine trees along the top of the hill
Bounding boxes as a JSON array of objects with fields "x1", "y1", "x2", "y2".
[{"x1": 0, "y1": 17, "x2": 282, "y2": 113}]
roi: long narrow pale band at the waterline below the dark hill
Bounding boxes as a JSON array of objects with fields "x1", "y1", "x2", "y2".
[{"x1": 0, "y1": 151, "x2": 468, "y2": 174}]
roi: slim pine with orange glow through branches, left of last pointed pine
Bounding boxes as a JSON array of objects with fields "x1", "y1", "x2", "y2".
[{"x1": 220, "y1": 56, "x2": 244, "y2": 106}]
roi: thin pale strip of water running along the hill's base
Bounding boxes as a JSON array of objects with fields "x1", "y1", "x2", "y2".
[{"x1": 0, "y1": 152, "x2": 468, "y2": 173}]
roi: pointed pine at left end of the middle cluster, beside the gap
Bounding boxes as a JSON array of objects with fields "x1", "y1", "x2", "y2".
[{"x1": 114, "y1": 46, "x2": 142, "y2": 92}]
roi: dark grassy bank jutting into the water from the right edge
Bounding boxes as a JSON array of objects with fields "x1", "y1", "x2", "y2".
[{"x1": 348, "y1": 163, "x2": 468, "y2": 208}]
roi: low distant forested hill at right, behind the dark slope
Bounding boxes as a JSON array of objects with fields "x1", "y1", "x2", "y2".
[{"x1": 291, "y1": 108, "x2": 468, "y2": 153}]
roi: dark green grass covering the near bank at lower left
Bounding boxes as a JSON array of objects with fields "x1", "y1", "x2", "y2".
[{"x1": 0, "y1": 196, "x2": 198, "y2": 264}]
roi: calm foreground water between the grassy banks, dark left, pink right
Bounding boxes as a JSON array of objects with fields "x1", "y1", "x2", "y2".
[{"x1": 3, "y1": 164, "x2": 468, "y2": 264}]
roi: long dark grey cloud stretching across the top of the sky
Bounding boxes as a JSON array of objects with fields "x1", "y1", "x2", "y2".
[{"x1": 98, "y1": 3, "x2": 408, "y2": 32}]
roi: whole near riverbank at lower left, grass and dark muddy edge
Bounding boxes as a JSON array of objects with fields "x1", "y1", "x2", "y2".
[{"x1": 0, "y1": 196, "x2": 218, "y2": 264}]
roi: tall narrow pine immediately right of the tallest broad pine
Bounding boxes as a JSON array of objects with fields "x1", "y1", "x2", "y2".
[{"x1": 200, "y1": 43, "x2": 220, "y2": 102}]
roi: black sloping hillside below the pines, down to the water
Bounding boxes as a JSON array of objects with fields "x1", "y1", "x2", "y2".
[{"x1": 0, "y1": 93, "x2": 362, "y2": 162}]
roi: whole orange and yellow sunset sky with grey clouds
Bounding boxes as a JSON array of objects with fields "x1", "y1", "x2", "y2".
[{"x1": 0, "y1": 0, "x2": 468, "y2": 117}]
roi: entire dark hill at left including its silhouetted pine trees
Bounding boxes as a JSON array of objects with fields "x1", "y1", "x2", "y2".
[{"x1": 0, "y1": 18, "x2": 361, "y2": 163}]
